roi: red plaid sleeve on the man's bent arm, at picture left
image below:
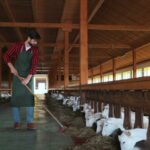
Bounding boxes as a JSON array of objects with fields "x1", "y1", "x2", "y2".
[{"x1": 3, "y1": 43, "x2": 21, "y2": 64}]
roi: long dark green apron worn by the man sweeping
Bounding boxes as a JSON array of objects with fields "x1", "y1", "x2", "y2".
[{"x1": 11, "y1": 47, "x2": 34, "y2": 107}]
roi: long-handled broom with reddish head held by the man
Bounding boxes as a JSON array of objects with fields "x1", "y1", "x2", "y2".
[{"x1": 17, "y1": 75, "x2": 67, "y2": 133}]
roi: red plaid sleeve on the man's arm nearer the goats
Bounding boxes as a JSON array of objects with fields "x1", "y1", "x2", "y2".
[{"x1": 29, "y1": 48, "x2": 39, "y2": 75}]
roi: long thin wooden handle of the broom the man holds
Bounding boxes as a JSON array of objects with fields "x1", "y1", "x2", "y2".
[{"x1": 17, "y1": 75, "x2": 64, "y2": 128}]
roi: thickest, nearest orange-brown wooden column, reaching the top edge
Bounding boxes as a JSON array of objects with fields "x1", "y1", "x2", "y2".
[{"x1": 80, "y1": 0, "x2": 88, "y2": 85}]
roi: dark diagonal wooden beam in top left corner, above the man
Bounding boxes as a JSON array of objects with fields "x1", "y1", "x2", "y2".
[{"x1": 0, "y1": 0, "x2": 23, "y2": 40}]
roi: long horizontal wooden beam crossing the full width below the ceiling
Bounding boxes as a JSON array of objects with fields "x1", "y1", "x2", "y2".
[{"x1": 0, "y1": 22, "x2": 150, "y2": 32}]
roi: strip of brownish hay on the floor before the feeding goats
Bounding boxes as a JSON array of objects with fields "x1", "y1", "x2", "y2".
[{"x1": 48, "y1": 95, "x2": 119, "y2": 150}]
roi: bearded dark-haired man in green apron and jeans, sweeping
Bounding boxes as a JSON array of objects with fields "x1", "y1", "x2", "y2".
[{"x1": 4, "y1": 30, "x2": 40, "y2": 129}]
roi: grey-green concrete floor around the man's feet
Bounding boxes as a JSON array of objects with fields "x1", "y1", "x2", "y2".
[{"x1": 0, "y1": 105, "x2": 73, "y2": 150}]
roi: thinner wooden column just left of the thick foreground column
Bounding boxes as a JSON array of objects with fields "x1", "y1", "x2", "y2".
[{"x1": 64, "y1": 31, "x2": 69, "y2": 89}]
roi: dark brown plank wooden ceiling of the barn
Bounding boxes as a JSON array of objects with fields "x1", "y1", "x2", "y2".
[{"x1": 0, "y1": 0, "x2": 150, "y2": 74}]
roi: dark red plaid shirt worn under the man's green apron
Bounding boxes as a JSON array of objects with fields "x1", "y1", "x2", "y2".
[{"x1": 4, "y1": 42, "x2": 39, "y2": 75}]
